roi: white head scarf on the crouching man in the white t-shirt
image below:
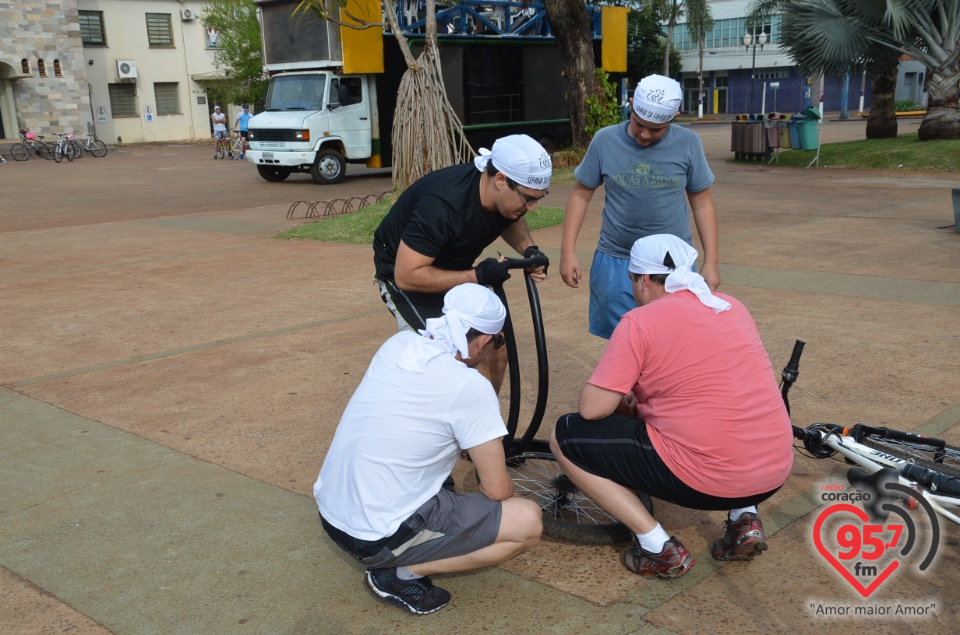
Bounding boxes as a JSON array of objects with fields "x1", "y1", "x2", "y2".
[{"x1": 397, "y1": 282, "x2": 507, "y2": 373}]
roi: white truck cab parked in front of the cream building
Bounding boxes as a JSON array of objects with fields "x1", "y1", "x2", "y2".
[{"x1": 246, "y1": 68, "x2": 376, "y2": 184}]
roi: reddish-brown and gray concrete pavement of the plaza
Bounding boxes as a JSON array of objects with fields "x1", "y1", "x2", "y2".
[{"x1": 0, "y1": 122, "x2": 960, "y2": 633}]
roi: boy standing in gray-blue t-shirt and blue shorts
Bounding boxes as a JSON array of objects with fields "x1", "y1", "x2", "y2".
[{"x1": 560, "y1": 75, "x2": 720, "y2": 339}]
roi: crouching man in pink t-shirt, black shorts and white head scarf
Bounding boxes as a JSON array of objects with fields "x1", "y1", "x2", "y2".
[{"x1": 550, "y1": 234, "x2": 793, "y2": 578}]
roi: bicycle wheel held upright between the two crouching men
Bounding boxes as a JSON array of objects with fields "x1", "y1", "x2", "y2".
[{"x1": 507, "y1": 448, "x2": 633, "y2": 545}]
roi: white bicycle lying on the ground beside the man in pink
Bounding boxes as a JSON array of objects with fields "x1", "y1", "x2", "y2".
[{"x1": 780, "y1": 340, "x2": 960, "y2": 524}]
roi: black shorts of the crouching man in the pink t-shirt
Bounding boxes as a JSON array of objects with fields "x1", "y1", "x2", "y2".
[{"x1": 556, "y1": 412, "x2": 780, "y2": 510}]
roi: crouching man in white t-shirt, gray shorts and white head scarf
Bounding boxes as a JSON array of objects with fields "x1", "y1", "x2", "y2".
[{"x1": 313, "y1": 283, "x2": 543, "y2": 615}]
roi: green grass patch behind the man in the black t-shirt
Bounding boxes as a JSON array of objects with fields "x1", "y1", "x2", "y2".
[{"x1": 275, "y1": 199, "x2": 563, "y2": 245}]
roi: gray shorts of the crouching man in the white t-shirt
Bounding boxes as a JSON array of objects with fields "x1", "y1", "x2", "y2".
[{"x1": 320, "y1": 489, "x2": 503, "y2": 569}]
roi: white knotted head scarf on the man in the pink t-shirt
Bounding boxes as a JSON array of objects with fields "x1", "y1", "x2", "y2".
[{"x1": 628, "y1": 234, "x2": 730, "y2": 313}]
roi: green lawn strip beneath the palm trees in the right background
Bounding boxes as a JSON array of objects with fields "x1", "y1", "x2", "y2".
[{"x1": 730, "y1": 133, "x2": 960, "y2": 172}]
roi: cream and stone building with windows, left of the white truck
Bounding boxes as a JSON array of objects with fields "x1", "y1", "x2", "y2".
[{"x1": 0, "y1": 0, "x2": 236, "y2": 144}]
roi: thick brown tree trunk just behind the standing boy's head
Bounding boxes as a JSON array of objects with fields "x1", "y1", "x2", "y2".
[{"x1": 544, "y1": 0, "x2": 600, "y2": 147}]
